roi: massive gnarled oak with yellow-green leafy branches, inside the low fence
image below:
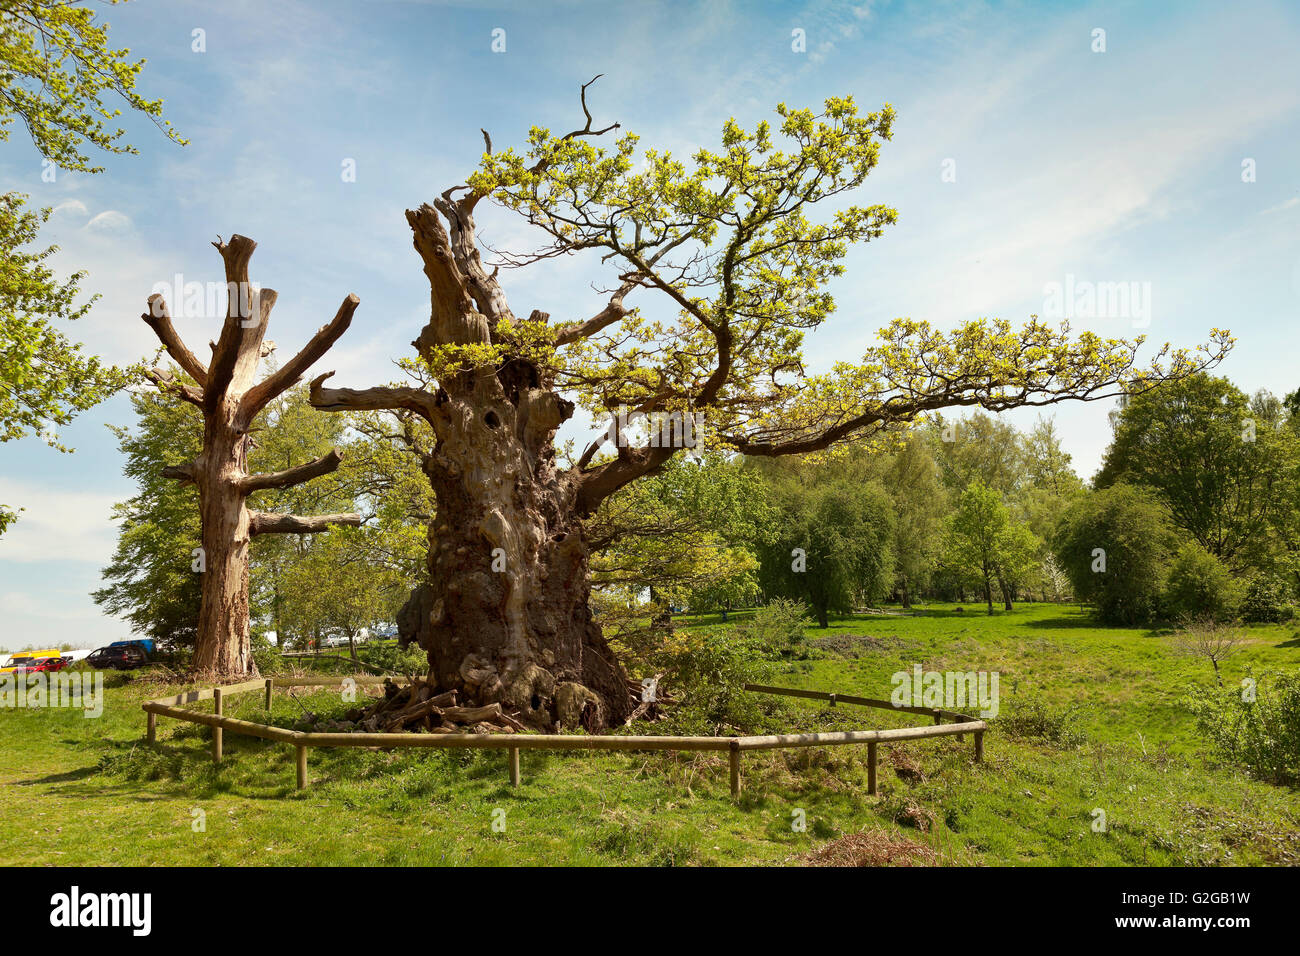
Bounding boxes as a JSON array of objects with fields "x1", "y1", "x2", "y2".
[{"x1": 311, "y1": 83, "x2": 1229, "y2": 728}]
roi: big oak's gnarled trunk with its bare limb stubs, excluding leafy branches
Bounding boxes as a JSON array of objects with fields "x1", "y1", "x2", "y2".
[{"x1": 311, "y1": 195, "x2": 655, "y2": 730}]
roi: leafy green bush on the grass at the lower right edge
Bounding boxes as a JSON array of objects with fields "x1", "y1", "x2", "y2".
[{"x1": 1188, "y1": 674, "x2": 1300, "y2": 787}]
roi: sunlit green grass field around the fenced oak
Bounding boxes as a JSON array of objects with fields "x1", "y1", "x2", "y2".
[{"x1": 0, "y1": 605, "x2": 1300, "y2": 865}]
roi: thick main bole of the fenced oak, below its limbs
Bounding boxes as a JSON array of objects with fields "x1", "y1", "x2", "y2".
[{"x1": 399, "y1": 389, "x2": 631, "y2": 730}]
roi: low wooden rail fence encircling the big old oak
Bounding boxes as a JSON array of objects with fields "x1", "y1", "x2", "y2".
[{"x1": 142, "y1": 674, "x2": 988, "y2": 797}]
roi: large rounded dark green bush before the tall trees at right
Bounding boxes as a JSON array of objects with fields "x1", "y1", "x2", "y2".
[{"x1": 1052, "y1": 484, "x2": 1177, "y2": 624}]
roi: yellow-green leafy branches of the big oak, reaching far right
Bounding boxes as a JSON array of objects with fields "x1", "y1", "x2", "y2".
[{"x1": 460, "y1": 83, "x2": 1231, "y2": 470}]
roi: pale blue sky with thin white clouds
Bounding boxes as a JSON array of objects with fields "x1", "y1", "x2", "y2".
[{"x1": 0, "y1": 0, "x2": 1300, "y2": 646}]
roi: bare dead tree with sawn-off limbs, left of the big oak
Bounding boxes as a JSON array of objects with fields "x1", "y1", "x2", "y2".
[{"x1": 140, "y1": 235, "x2": 361, "y2": 679}]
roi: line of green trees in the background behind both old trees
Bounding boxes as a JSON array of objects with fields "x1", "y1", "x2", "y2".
[{"x1": 95, "y1": 373, "x2": 1300, "y2": 658}]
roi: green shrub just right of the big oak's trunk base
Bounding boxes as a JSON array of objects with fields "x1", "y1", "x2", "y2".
[{"x1": 655, "y1": 628, "x2": 787, "y2": 736}]
